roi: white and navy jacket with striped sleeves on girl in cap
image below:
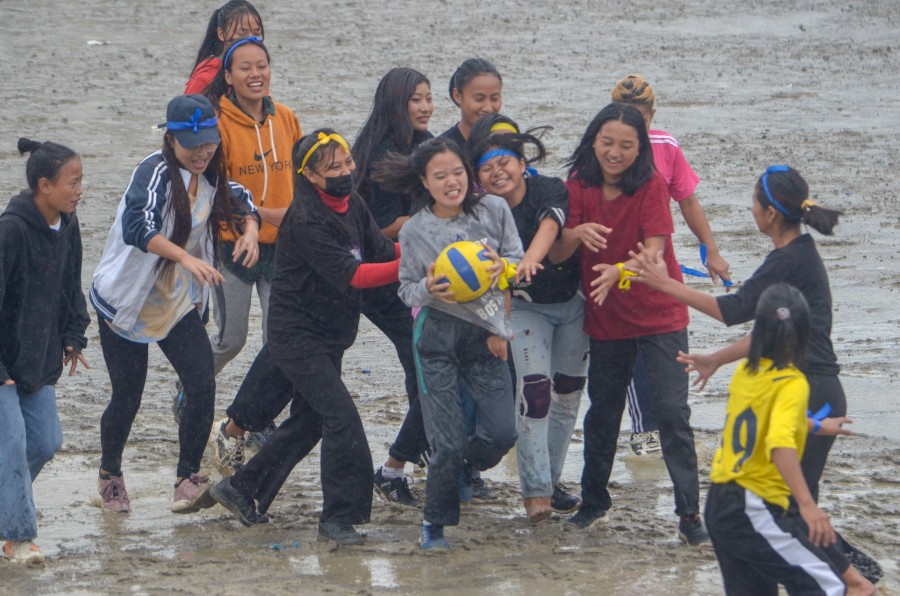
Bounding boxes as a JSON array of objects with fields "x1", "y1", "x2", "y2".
[{"x1": 90, "y1": 150, "x2": 259, "y2": 331}]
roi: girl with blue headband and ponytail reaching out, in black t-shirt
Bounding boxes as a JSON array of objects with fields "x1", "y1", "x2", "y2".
[{"x1": 629, "y1": 166, "x2": 877, "y2": 587}]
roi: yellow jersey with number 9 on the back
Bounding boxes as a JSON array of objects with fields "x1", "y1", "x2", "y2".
[{"x1": 710, "y1": 358, "x2": 809, "y2": 509}]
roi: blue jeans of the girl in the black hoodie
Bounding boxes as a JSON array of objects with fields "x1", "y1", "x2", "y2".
[{"x1": 0, "y1": 385, "x2": 62, "y2": 540}]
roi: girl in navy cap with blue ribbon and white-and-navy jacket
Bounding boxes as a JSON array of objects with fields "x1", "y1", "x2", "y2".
[{"x1": 91, "y1": 95, "x2": 259, "y2": 513}]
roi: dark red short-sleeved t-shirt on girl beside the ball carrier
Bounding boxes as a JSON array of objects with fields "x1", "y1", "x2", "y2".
[{"x1": 566, "y1": 173, "x2": 688, "y2": 340}]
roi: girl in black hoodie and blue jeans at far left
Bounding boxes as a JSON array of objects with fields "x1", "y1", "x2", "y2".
[{"x1": 0, "y1": 138, "x2": 90, "y2": 565}]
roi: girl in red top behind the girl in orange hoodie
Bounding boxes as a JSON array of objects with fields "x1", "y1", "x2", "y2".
[{"x1": 184, "y1": 0, "x2": 265, "y2": 95}]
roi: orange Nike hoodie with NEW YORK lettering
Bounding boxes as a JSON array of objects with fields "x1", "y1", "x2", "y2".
[{"x1": 219, "y1": 96, "x2": 303, "y2": 244}]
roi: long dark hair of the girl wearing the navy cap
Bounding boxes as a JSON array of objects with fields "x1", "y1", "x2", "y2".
[{"x1": 154, "y1": 132, "x2": 242, "y2": 276}]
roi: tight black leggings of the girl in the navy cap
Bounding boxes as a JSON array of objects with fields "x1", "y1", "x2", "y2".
[{"x1": 97, "y1": 310, "x2": 216, "y2": 478}]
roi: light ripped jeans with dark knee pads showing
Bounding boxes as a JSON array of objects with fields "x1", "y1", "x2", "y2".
[{"x1": 510, "y1": 294, "x2": 588, "y2": 498}]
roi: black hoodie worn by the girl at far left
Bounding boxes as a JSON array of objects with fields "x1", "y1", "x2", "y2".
[{"x1": 0, "y1": 191, "x2": 91, "y2": 395}]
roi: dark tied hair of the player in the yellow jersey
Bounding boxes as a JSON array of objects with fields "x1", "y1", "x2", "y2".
[{"x1": 747, "y1": 283, "x2": 810, "y2": 373}]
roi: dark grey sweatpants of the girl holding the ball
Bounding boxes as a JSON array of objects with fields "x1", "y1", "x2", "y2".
[{"x1": 413, "y1": 308, "x2": 516, "y2": 526}]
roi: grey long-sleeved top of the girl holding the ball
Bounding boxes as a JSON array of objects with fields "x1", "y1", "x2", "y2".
[{"x1": 398, "y1": 195, "x2": 523, "y2": 339}]
